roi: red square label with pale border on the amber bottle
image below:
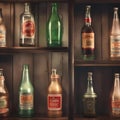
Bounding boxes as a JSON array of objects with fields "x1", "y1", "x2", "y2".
[{"x1": 48, "y1": 94, "x2": 62, "y2": 110}]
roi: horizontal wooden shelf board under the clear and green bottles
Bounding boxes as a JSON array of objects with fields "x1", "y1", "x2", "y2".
[{"x1": 0, "y1": 47, "x2": 69, "y2": 54}]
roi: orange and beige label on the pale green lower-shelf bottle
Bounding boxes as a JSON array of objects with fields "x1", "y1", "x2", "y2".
[{"x1": 19, "y1": 94, "x2": 33, "y2": 110}]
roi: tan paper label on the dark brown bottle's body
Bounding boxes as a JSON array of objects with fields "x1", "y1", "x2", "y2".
[{"x1": 82, "y1": 33, "x2": 94, "y2": 49}]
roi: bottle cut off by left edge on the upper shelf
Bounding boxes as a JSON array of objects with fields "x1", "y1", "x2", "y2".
[{"x1": 0, "y1": 8, "x2": 6, "y2": 47}]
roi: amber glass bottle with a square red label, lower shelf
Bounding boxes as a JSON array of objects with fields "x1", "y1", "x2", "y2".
[{"x1": 47, "y1": 69, "x2": 62, "y2": 117}]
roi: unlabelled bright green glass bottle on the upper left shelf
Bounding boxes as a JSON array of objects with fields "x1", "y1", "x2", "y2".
[{"x1": 46, "y1": 3, "x2": 63, "y2": 47}]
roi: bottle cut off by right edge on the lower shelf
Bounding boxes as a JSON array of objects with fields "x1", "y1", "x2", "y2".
[{"x1": 112, "y1": 73, "x2": 120, "y2": 117}]
